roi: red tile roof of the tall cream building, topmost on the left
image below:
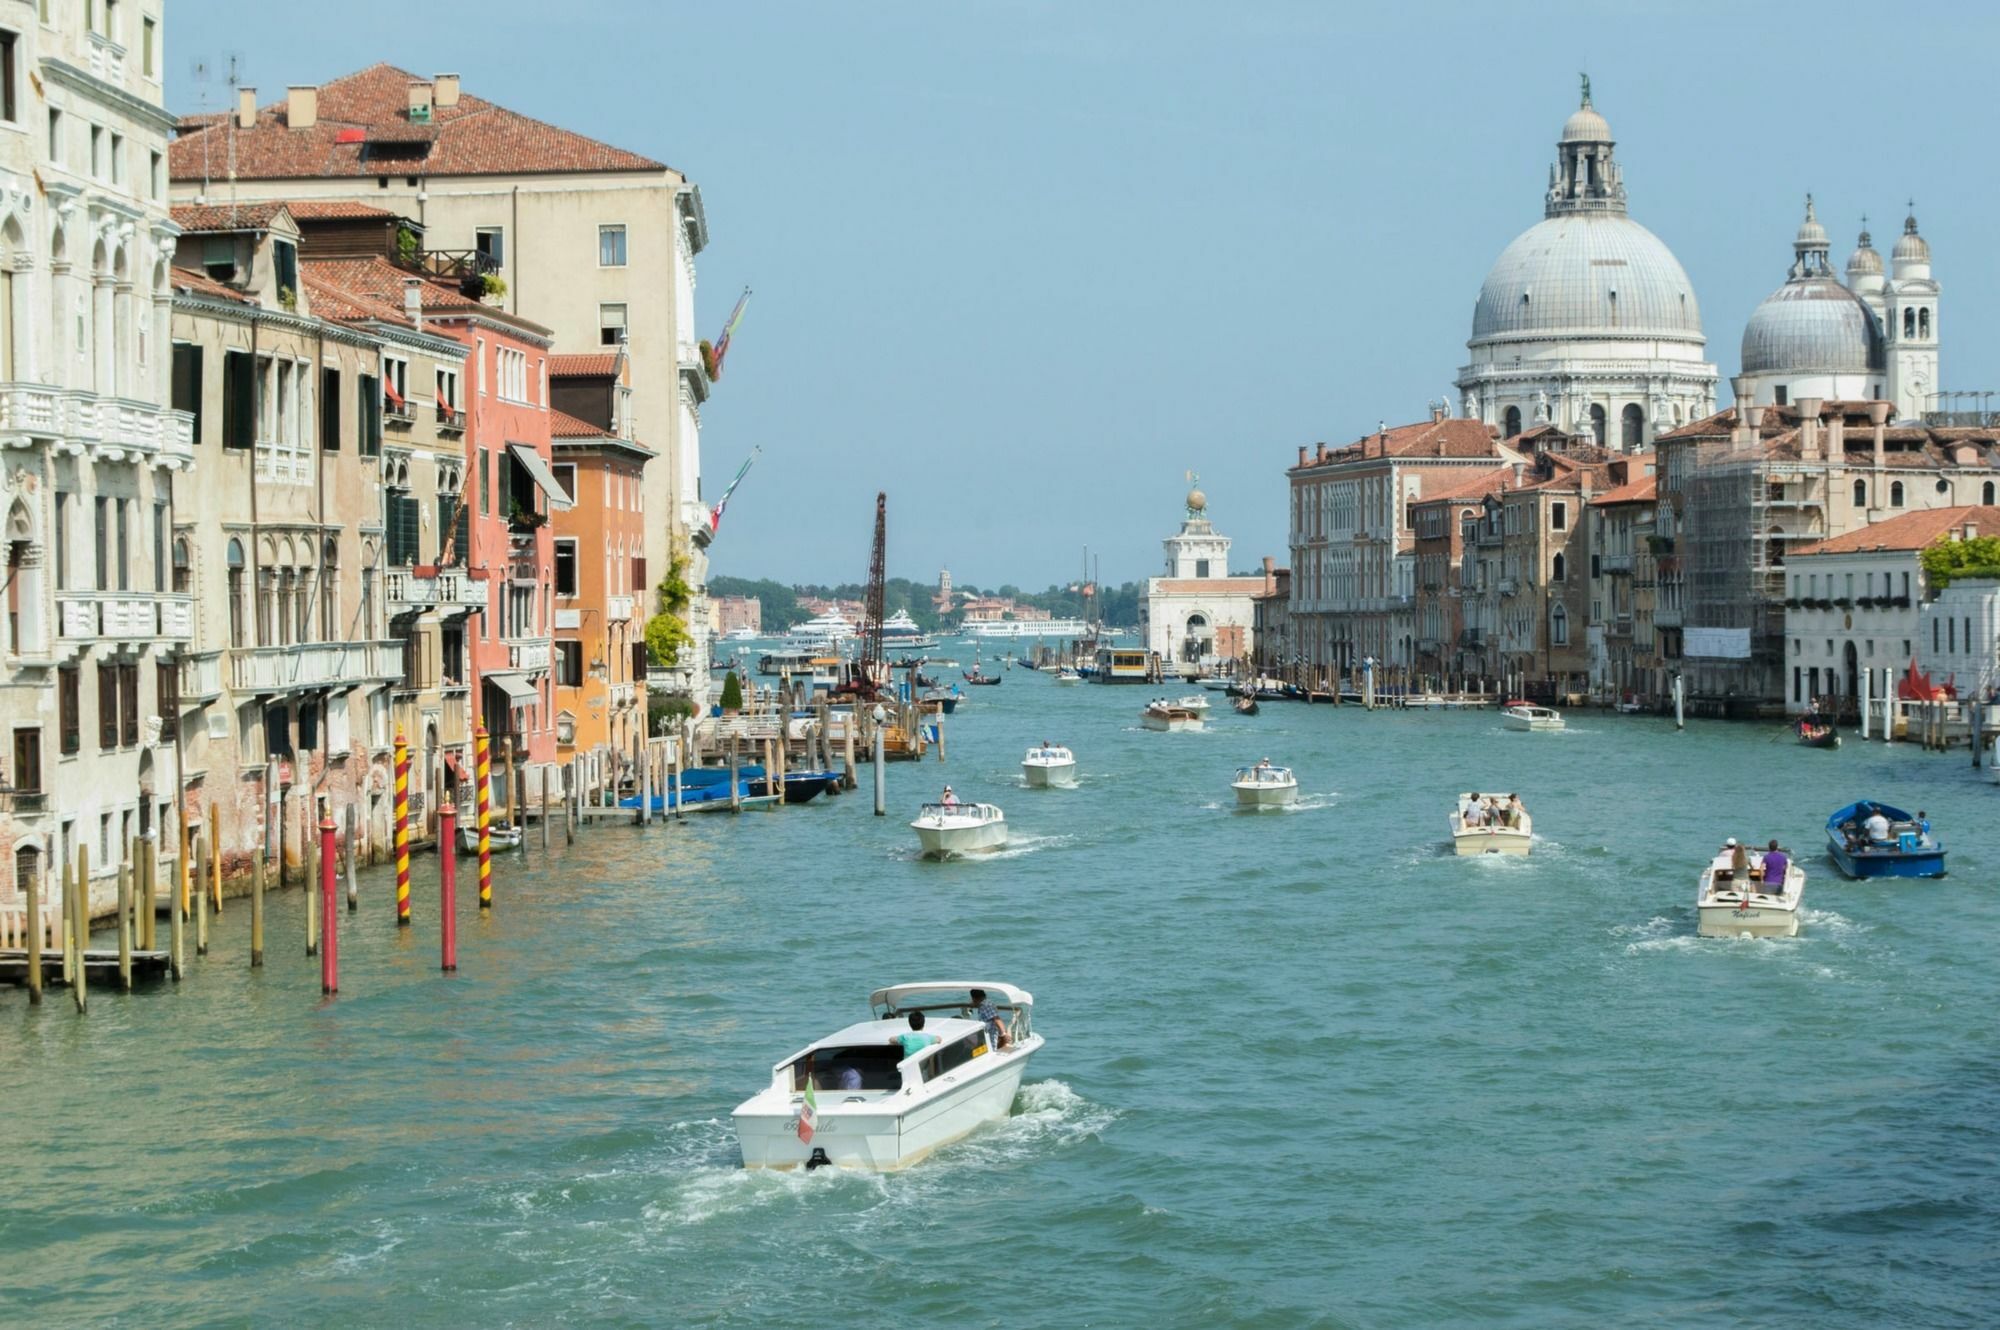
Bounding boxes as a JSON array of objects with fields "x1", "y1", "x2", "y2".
[{"x1": 168, "y1": 64, "x2": 668, "y2": 180}]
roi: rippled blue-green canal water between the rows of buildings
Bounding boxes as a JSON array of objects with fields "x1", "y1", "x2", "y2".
[{"x1": 0, "y1": 670, "x2": 2000, "y2": 1326}]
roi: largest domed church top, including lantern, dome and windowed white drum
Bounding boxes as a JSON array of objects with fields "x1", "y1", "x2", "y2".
[{"x1": 1458, "y1": 78, "x2": 1716, "y2": 450}]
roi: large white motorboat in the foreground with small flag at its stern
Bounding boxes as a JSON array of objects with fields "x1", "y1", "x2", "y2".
[{"x1": 736, "y1": 982, "x2": 1042, "y2": 1172}]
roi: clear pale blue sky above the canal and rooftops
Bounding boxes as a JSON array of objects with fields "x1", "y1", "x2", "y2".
[{"x1": 166, "y1": 0, "x2": 2000, "y2": 588}]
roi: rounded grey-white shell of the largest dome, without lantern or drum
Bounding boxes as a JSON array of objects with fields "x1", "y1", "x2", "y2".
[{"x1": 1470, "y1": 212, "x2": 1704, "y2": 346}]
